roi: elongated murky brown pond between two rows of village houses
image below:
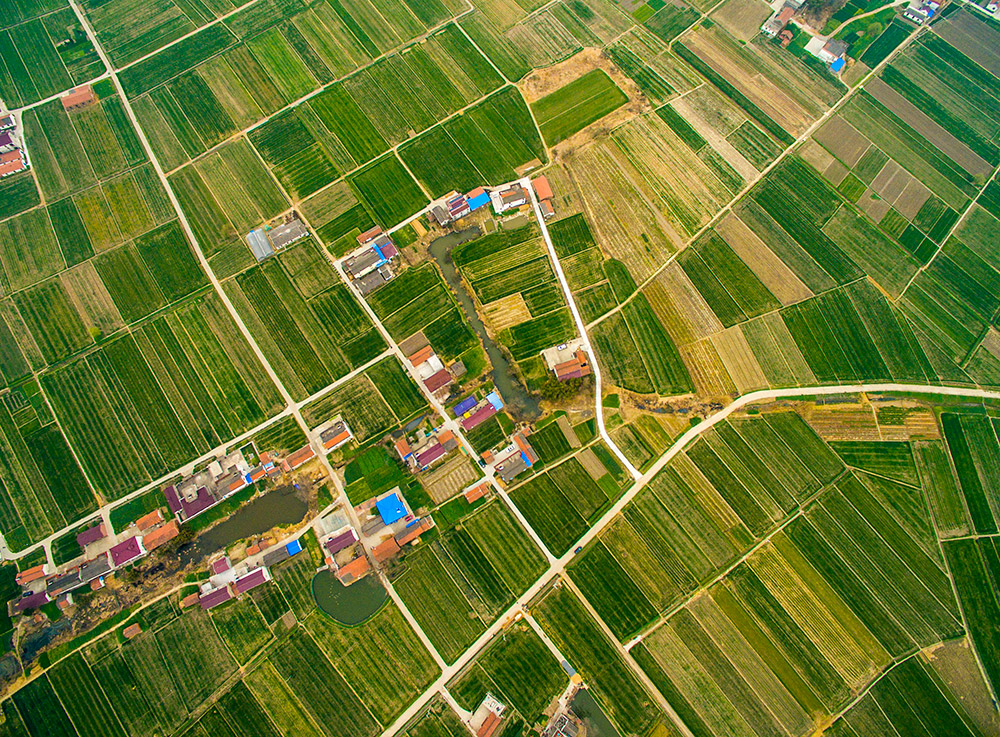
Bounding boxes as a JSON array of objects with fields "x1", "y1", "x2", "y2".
[{"x1": 180, "y1": 486, "x2": 309, "y2": 566}]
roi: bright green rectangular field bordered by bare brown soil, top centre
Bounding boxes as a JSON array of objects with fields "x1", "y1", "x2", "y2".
[{"x1": 531, "y1": 69, "x2": 628, "y2": 146}]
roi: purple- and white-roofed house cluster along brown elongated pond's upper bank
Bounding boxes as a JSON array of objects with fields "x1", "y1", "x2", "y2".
[{"x1": 163, "y1": 442, "x2": 276, "y2": 523}]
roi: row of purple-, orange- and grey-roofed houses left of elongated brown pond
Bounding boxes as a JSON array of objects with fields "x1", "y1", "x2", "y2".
[{"x1": 9, "y1": 509, "x2": 180, "y2": 614}]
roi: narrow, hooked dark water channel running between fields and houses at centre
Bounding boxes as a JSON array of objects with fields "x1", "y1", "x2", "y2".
[{"x1": 430, "y1": 226, "x2": 541, "y2": 420}]
